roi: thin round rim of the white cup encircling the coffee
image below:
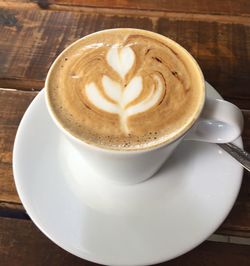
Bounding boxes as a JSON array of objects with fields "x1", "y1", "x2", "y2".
[{"x1": 44, "y1": 28, "x2": 206, "y2": 154}]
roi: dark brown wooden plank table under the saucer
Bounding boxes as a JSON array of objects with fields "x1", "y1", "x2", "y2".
[{"x1": 0, "y1": 0, "x2": 250, "y2": 266}]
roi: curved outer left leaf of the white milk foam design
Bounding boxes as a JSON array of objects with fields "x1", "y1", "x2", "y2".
[{"x1": 85, "y1": 82, "x2": 119, "y2": 113}]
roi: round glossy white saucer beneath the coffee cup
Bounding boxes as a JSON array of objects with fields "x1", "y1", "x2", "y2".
[{"x1": 13, "y1": 84, "x2": 243, "y2": 266}]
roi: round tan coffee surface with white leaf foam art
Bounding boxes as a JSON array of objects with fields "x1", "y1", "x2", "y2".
[{"x1": 46, "y1": 29, "x2": 204, "y2": 150}]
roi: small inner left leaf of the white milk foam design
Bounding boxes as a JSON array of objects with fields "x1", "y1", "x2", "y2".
[{"x1": 102, "y1": 75, "x2": 122, "y2": 102}]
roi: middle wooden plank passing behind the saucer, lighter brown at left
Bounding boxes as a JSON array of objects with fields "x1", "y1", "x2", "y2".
[{"x1": 0, "y1": 89, "x2": 250, "y2": 237}]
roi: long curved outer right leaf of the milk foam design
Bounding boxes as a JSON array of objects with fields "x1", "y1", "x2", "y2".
[{"x1": 126, "y1": 75, "x2": 163, "y2": 116}]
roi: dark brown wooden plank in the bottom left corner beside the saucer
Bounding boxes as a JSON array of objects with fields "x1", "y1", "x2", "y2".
[{"x1": 0, "y1": 218, "x2": 97, "y2": 266}]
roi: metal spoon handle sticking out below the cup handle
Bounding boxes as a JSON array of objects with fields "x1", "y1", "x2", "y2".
[{"x1": 218, "y1": 143, "x2": 250, "y2": 172}]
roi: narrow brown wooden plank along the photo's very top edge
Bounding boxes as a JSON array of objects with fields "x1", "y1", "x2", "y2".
[{"x1": 8, "y1": 0, "x2": 250, "y2": 16}]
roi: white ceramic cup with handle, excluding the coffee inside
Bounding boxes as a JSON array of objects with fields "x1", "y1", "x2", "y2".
[{"x1": 45, "y1": 29, "x2": 243, "y2": 184}]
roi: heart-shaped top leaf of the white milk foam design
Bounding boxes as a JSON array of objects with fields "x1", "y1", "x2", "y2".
[{"x1": 107, "y1": 45, "x2": 135, "y2": 79}]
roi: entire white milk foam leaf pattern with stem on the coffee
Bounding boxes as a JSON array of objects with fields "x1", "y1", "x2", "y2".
[{"x1": 85, "y1": 46, "x2": 163, "y2": 134}]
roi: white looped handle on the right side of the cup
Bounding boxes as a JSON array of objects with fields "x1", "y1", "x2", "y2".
[{"x1": 184, "y1": 98, "x2": 243, "y2": 143}]
